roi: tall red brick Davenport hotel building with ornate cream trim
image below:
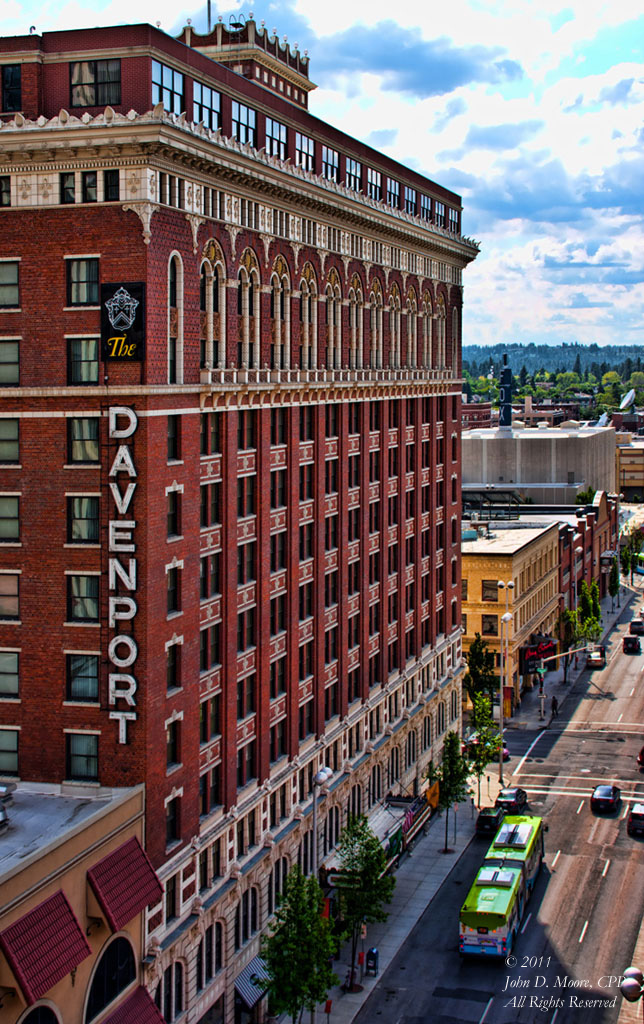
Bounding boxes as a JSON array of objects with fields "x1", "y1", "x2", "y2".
[{"x1": 0, "y1": 22, "x2": 477, "y2": 1024}]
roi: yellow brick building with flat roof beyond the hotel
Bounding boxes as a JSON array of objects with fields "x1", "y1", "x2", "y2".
[{"x1": 462, "y1": 522, "x2": 559, "y2": 715}]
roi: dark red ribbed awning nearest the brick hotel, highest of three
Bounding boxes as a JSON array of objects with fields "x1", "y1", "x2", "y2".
[{"x1": 87, "y1": 836, "x2": 163, "y2": 932}]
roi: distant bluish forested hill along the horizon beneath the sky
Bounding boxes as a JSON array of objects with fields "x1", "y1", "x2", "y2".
[{"x1": 463, "y1": 342, "x2": 644, "y2": 380}]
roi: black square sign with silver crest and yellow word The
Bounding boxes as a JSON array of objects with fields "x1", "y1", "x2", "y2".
[{"x1": 100, "y1": 281, "x2": 145, "y2": 362}]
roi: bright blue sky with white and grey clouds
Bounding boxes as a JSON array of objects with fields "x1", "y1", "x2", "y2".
[{"x1": 2, "y1": 0, "x2": 644, "y2": 345}]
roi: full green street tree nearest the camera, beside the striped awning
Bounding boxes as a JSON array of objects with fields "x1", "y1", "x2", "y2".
[{"x1": 262, "y1": 865, "x2": 338, "y2": 1024}]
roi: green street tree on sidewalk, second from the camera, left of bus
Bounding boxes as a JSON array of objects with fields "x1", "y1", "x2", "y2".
[{"x1": 337, "y1": 814, "x2": 396, "y2": 988}]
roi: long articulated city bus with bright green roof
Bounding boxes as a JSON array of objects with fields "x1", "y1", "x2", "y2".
[{"x1": 459, "y1": 815, "x2": 544, "y2": 956}]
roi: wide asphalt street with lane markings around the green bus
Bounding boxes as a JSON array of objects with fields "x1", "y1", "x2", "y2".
[{"x1": 355, "y1": 614, "x2": 644, "y2": 1024}]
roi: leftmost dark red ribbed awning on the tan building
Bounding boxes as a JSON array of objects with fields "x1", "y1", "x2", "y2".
[{"x1": 0, "y1": 890, "x2": 91, "y2": 1006}]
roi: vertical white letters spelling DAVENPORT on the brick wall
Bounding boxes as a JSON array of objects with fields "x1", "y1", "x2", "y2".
[{"x1": 108, "y1": 406, "x2": 138, "y2": 743}]
